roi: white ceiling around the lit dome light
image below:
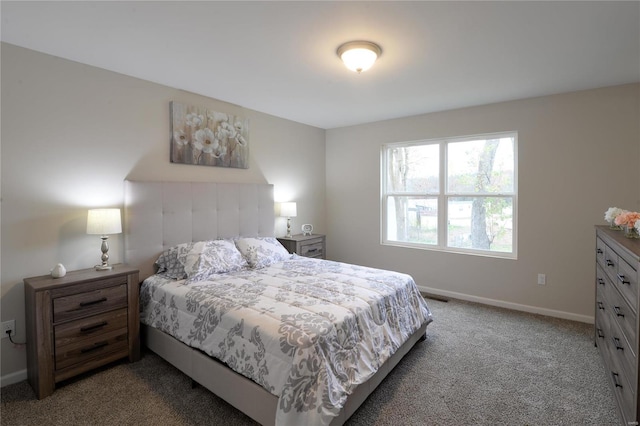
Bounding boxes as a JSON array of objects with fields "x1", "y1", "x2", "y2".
[{"x1": 0, "y1": 1, "x2": 640, "y2": 129}]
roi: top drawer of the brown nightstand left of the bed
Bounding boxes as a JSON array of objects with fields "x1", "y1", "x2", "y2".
[{"x1": 53, "y1": 283, "x2": 127, "y2": 323}]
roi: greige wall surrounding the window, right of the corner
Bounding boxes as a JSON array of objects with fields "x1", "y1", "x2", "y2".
[{"x1": 326, "y1": 84, "x2": 640, "y2": 322}]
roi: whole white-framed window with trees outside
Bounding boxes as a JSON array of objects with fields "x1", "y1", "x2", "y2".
[{"x1": 381, "y1": 132, "x2": 517, "y2": 258}]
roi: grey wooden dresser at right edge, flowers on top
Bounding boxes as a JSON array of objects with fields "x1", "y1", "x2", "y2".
[{"x1": 595, "y1": 226, "x2": 640, "y2": 425}]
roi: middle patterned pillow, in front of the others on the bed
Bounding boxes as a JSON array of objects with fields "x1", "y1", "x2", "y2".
[{"x1": 184, "y1": 240, "x2": 248, "y2": 282}]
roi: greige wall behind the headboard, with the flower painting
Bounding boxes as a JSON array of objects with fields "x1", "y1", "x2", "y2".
[{"x1": 0, "y1": 44, "x2": 325, "y2": 383}]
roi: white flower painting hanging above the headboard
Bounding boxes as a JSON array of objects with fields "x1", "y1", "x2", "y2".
[{"x1": 171, "y1": 102, "x2": 249, "y2": 169}]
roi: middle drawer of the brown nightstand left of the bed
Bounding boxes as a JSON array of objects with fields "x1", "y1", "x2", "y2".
[{"x1": 54, "y1": 308, "x2": 128, "y2": 351}]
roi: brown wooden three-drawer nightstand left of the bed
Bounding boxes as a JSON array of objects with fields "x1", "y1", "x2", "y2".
[{"x1": 24, "y1": 265, "x2": 140, "y2": 399}]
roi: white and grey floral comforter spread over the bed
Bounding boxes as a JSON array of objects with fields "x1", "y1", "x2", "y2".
[{"x1": 140, "y1": 256, "x2": 431, "y2": 425}]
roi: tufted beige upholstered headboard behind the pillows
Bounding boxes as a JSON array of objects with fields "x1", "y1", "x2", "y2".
[{"x1": 124, "y1": 181, "x2": 275, "y2": 280}]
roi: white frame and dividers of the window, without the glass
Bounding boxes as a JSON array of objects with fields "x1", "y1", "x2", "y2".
[{"x1": 380, "y1": 131, "x2": 518, "y2": 259}]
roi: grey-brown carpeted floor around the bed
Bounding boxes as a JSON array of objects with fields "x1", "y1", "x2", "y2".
[{"x1": 0, "y1": 299, "x2": 620, "y2": 426}]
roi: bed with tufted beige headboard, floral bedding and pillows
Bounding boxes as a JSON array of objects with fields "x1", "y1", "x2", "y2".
[{"x1": 125, "y1": 181, "x2": 431, "y2": 425}]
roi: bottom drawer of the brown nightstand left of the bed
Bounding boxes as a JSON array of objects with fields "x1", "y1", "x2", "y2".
[{"x1": 56, "y1": 327, "x2": 129, "y2": 370}]
